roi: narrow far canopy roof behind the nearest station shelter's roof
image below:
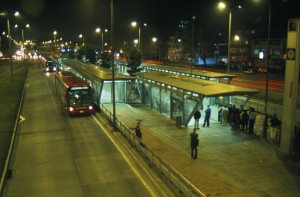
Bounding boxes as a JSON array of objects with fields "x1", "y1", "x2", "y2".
[{"x1": 141, "y1": 63, "x2": 236, "y2": 79}]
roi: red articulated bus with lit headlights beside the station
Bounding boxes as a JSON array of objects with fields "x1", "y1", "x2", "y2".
[{"x1": 55, "y1": 71, "x2": 94, "y2": 115}]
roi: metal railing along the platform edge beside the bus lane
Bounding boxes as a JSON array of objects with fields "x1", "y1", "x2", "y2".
[{"x1": 100, "y1": 104, "x2": 205, "y2": 196}]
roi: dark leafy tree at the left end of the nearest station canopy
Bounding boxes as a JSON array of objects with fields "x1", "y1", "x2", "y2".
[{"x1": 126, "y1": 47, "x2": 143, "y2": 76}]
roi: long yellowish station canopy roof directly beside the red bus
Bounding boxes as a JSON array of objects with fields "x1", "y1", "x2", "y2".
[{"x1": 62, "y1": 59, "x2": 135, "y2": 81}]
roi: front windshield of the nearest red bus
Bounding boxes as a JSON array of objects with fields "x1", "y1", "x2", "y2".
[{"x1": 68, "y1": 89, "x2": 92, "y2": 107}]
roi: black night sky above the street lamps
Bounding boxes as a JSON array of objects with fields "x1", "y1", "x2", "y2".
[{"x1": 0, "y1": 0, "x2": 300, "y2": 48}]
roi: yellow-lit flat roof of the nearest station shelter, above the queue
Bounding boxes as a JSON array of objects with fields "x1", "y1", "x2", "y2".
[{"x1": 135, "y1": 71, "x2": 260, "y2": 97}]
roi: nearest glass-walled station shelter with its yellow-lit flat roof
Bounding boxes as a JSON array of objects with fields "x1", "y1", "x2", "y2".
[{"x1": 135, "y1": 72, "x2": 259, "y2": 125}]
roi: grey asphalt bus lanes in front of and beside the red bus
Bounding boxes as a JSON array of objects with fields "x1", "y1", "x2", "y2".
[{"x1": 3, "y1": 62, "x2": 173, "y2": 197}]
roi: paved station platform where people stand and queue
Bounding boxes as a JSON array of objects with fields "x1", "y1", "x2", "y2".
[{"x1": 105, "y1": 104, "x2": 300, "y2": 197}]
